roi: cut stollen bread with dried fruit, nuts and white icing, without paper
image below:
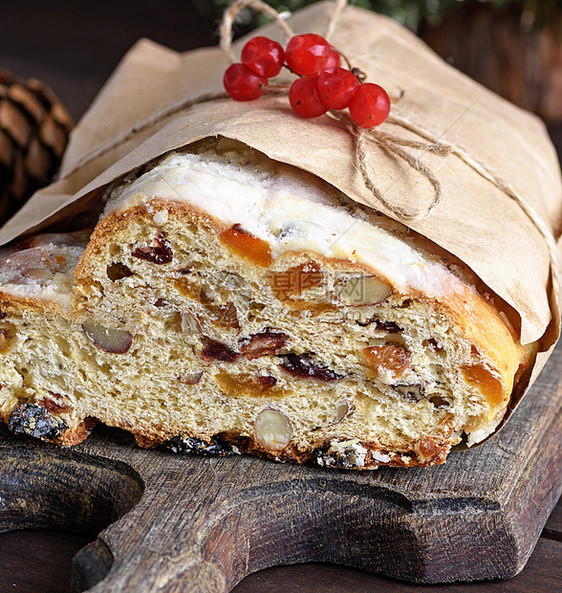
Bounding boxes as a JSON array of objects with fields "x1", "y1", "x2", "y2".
[{"x1": 0, "y1": 139, "x2": 530, "y2": 468}]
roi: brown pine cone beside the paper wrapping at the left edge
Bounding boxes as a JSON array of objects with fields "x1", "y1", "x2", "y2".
[{"x1": 0, "y1": 70, "x2": 72, "y2": 224}]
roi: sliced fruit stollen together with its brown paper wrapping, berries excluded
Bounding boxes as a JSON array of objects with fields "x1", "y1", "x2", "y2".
[{"x1": 0, "y1": 2, "x2": 562, "y2": 469}]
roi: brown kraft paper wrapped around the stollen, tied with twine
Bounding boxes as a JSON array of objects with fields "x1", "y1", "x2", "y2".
[{"x1": 0, "y1": 2, "x2": 562, "y2": 434}]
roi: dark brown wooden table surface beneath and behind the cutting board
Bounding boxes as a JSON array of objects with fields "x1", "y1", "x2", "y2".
[{"x1": 0, "y1": 0, "x2": 562, "y2": 593}]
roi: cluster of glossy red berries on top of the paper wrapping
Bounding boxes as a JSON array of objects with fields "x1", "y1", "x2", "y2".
[{"x1": 223, "y1": 33, "x2": 390, "y2": 128}]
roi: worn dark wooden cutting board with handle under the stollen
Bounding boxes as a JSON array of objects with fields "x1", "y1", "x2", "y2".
[{"x1": 0, "y1": 347, "x2": 562, "y2": 593}]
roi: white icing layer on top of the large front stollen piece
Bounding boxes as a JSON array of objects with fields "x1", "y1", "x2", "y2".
[{"x1": 105, "y1": 152, "x2": 460, "y2": 296}]
